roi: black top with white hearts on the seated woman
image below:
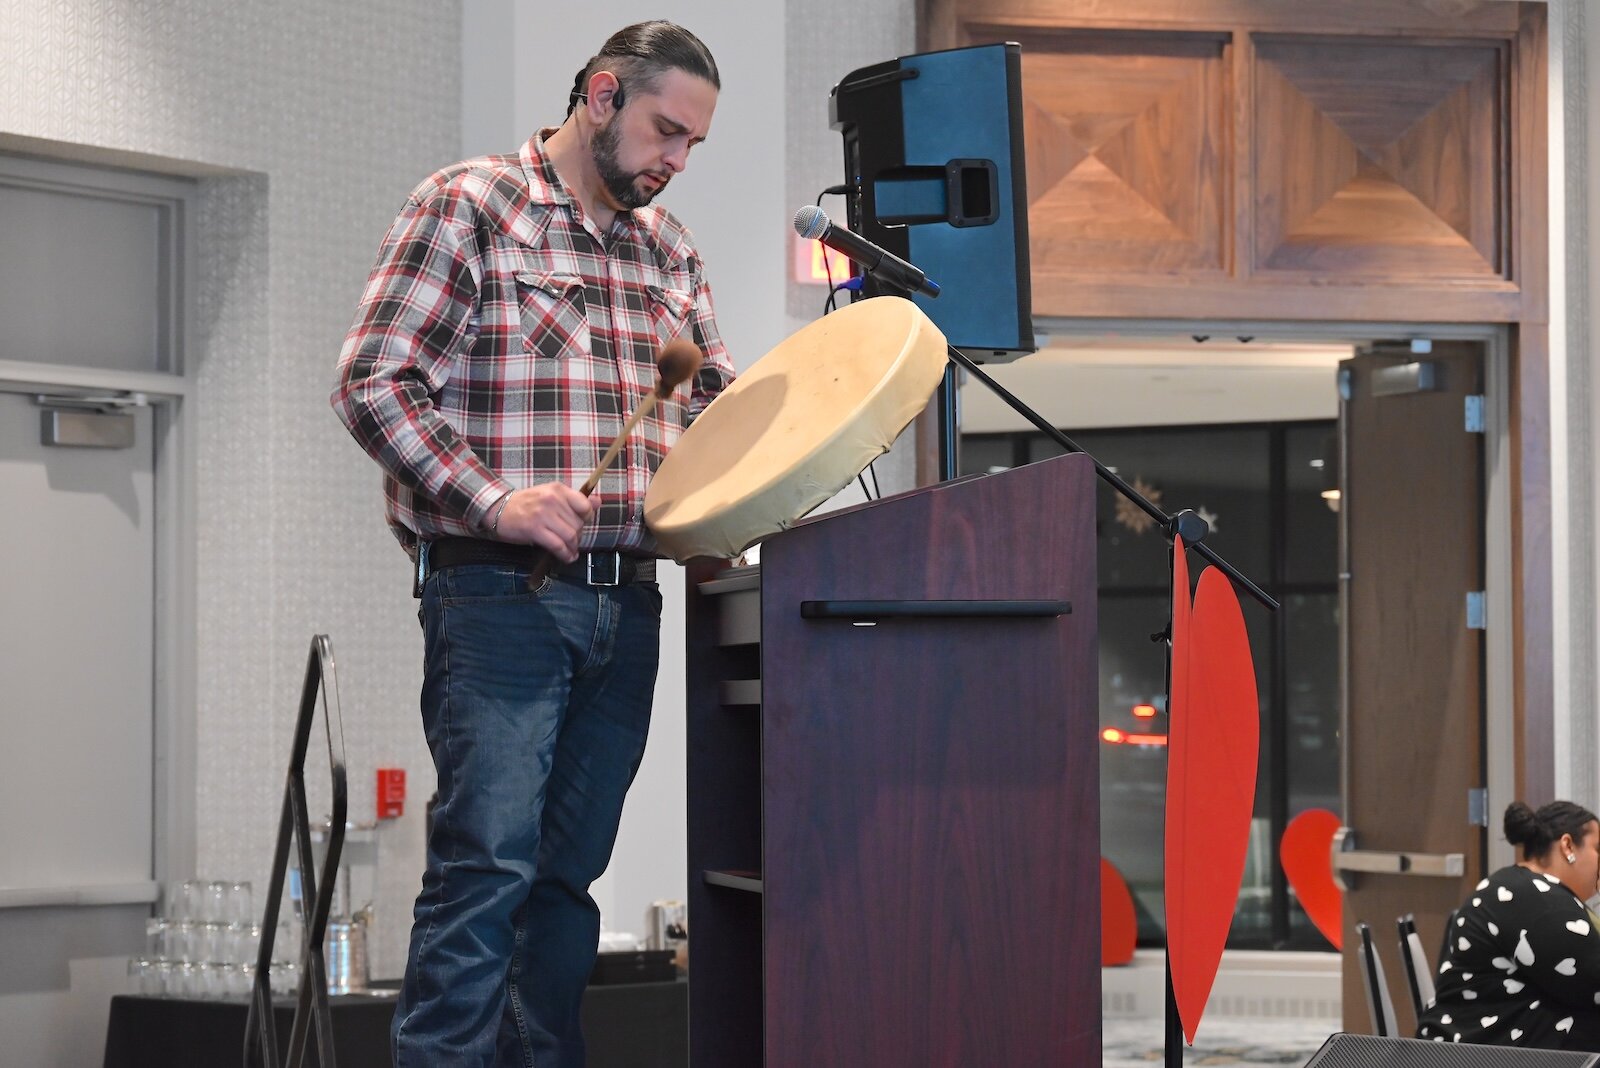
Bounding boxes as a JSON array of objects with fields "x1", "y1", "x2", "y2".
[{"x1": 1418, "y1": 865, "x2": 1600, "y2": 1049}]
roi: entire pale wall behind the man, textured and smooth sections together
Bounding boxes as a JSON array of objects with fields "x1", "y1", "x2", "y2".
[{"x1": 0, "y1": 0, "x2": 912, "y2": 1042}]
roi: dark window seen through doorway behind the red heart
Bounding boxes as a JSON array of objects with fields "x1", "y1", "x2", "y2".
[{"x1": 962, "y1": 420, "x2": 1339, "y2": 950}]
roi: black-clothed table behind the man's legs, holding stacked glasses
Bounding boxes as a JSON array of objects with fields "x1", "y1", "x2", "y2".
[{"x1": 106, "y1": 980, "x2": 690, "y2": 1068}]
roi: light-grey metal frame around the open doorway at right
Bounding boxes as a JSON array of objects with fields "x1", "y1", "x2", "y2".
[{"x1": 1024, "y1": 310, "x2": 1526, "y2": 871}]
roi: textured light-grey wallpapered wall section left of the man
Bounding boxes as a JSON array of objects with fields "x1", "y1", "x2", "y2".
[{"x1": 0, "y1": 0, "x2": 461, "y2": 975}]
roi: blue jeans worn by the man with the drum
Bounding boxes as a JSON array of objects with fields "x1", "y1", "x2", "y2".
[{"x1": 392, "y1": 564, "x2": 661, "y2": 1068}]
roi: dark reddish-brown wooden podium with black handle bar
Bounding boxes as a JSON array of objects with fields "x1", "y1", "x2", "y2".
[{"x1": 688, "y1": 456, "x2": 1107, "y2": 1068}]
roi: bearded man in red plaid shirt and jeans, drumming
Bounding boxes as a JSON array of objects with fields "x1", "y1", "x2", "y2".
[{"x1": 333, "y1": 22, "x2": 733, "y2": 1068}]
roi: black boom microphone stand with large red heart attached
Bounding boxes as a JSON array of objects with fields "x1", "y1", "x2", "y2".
[{"x1": 874, "y1": 268, "x2": 1280, "y2": 1068}]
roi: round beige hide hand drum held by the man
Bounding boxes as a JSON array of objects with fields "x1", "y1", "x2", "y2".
[{"x1": 645, "y1": 297, "x2": 946, "y2": 561}]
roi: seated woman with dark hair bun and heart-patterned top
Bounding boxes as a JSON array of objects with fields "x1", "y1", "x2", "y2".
[{"x1": 1418, "y1": 801, "x2": 1600, "y2": 1052}]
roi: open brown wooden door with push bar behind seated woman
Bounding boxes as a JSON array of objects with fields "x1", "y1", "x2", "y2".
[{"x1": 1339, "y1": 342, "x2": 1485, "y2": 1034}]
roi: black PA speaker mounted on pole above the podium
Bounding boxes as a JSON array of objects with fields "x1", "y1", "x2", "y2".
[{"x1": 829, "y1": 45, "x2": 1035, "y2": 363}]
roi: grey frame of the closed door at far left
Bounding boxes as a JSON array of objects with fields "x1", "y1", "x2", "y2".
[{"x1": 0, "y1": 153, "x2": 202, "y2": 908}]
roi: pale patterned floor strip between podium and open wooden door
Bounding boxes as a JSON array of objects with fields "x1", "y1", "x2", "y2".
[{"x1": 1104, "y1": 1017, "x2": 1339, "y2": 1068}]
